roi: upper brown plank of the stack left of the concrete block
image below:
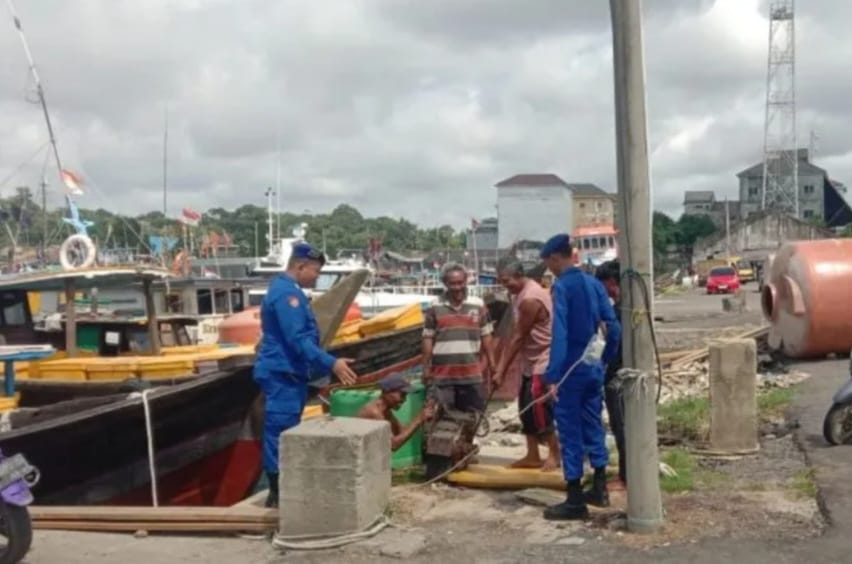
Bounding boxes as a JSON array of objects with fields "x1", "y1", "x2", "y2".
[{"x1": 29, "y1": 505, "x2": 278, "y2": 523}]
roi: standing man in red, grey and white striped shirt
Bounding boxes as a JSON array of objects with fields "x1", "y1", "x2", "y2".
[{"x1": 423, "y1": 264, "x2": 495, "y2": 411}]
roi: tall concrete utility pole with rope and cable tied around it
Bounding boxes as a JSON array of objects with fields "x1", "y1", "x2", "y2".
[{"x1": 610, "y1": 0, "x2": 663, "y2": 532}]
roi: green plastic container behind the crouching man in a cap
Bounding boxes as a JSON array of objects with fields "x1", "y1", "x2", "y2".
[{"x1": 329, "y1": 381, "x2": 426, "y2": 470}]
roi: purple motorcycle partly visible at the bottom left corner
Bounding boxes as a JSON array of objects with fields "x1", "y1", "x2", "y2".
[{"x1": 0, "y1": 451, "x2": 40, "y2": 564}]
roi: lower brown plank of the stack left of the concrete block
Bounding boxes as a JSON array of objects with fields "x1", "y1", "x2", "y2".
[{"x1": 33, "y1": 520, "x2": 276, "y2": 533}]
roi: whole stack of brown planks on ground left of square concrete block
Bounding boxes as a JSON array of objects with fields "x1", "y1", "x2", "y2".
[{"x1": 29, "y1": 506, "x2": 278, "y2": 533}]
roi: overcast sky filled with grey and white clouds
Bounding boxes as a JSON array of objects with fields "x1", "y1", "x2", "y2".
[{"x1": 0, "y1": 0, "x2": 852, "y2": 226}]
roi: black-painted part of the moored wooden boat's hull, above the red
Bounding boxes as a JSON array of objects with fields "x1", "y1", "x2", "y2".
[{"x1": 0, "y1": 366, "x2": 258, "y2": 504}]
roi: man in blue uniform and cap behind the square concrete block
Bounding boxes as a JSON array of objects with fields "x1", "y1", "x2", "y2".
[{"x1": 254, "y1": 243, "x2": 357, "y2": 507}]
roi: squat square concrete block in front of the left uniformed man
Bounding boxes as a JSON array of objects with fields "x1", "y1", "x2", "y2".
[{"x1": 279, "y1": 417, "x2": 391, "y2": 537}]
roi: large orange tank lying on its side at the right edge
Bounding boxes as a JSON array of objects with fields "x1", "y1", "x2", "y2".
[{"x1": 761, "y1": 239, "x2": 852, "y2": 358}]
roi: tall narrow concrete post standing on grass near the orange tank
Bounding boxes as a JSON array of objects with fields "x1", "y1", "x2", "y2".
[{"x1": 709, "y1": 339, "x2": 759, "y2": 454}]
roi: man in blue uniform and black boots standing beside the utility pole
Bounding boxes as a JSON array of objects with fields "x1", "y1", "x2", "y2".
[{"x1": 541, "y1": 234, "x2": 621, "y2": 520}]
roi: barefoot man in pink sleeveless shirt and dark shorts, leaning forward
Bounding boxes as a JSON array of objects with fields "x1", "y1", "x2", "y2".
[{"x1": 494, "y1": 260, "x2": 560, "y2": 471}]
